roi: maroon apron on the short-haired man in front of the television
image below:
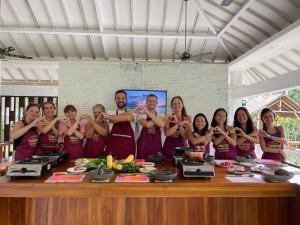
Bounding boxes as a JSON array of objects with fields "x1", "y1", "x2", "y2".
[{"x1": 137, "y1": 117, "x2": 162, "y2": 159}]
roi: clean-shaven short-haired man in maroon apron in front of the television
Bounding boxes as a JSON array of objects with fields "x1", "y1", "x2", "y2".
[{"x1": 137, "y1": 94, "x2": 165, "y2": 159}]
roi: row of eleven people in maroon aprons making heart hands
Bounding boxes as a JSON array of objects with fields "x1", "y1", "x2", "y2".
[{"x1": 11, "y1": 90, "x2": 286, "y2": 161}]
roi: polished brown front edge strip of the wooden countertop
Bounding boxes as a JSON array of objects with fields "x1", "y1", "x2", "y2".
[{"x1": 0, "y1": 183, "x2": 297, "y2": 198}]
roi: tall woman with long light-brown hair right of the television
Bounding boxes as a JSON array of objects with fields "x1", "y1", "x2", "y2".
[{"x1": 163, "y1": 96, "x2": 191, "y2": 159}]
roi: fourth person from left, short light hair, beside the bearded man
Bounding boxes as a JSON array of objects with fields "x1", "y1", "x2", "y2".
[{"x1": 84, "y1": 104, "x2": 108, "y2": 158}]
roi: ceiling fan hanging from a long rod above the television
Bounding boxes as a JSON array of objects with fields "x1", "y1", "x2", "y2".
[{"x1": 174, "y1": 0, "x2": 213, "y2": 63}]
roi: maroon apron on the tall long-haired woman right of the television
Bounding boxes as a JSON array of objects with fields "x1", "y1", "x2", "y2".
[{"x1": 163, "y1": 117, "x2": 188, "y2": 159}]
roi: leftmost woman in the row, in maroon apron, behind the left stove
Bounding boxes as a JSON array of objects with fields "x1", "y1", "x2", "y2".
[{"x1": 10, "y1": 103, "x2": 45, "y2": 161}]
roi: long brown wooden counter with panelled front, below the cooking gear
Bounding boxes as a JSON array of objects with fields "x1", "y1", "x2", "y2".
[{"x1": 0, "y1": 161, "x2": 300, "y2": 225}]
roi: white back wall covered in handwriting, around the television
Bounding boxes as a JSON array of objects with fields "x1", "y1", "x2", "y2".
[{"x1": 58, "y1": 61, "x2": 228, "y2": 121}]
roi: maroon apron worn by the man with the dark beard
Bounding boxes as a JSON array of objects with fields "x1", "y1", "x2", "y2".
[{"x1": 106, "y1": 111, "x2": 136, "y2": 159}]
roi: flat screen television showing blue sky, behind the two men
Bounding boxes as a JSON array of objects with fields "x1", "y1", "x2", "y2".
[{"x1": 124, "y1": 89, "x2": 167, "y2": 114}]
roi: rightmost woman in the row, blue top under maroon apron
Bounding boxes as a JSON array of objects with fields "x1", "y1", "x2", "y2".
[{"x1": 259, "y1": 108, "x2": 287, "y2": 161}]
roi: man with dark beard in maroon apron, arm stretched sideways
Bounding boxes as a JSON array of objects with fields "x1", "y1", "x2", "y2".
[{"x1": 102, "y1": 90, "x2": 136, "y2": 159}]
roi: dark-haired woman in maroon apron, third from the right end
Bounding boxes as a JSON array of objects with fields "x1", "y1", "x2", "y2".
[{"x1": 211, "y1": 108, "x2": 237, "y2": 160}]
